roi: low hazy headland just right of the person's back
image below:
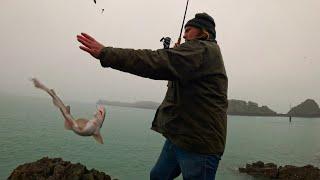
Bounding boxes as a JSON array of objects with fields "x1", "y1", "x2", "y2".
[{"x1": 228, "y1": 99, "x2": 277, "y2": 116}]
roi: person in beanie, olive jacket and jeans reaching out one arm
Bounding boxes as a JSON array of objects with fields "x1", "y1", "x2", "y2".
[{"x1": 77, "y1": 13, "x2": 228, "y2": 180}]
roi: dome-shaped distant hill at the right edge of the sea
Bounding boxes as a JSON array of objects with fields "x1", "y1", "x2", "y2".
[{"x1": 287, "y1": 99, "x2": 320, "y2": 117}]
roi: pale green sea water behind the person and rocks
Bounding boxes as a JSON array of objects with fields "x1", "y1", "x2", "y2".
[{"x1": 0, "y1": 95, "x2": 320, "y2": 180}]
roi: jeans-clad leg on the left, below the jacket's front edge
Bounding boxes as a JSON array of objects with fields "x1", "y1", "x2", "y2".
[{"x1": 150, "y1": 140, "x2": 181, "y2": 180}]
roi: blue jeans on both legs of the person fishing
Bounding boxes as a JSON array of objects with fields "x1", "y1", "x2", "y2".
[{"x1": 150, "y1": 140, "x2": 220, "y2": 180}]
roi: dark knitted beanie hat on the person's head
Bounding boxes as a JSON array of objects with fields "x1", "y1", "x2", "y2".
[{"x1": 184, "y1": 13, "x2": 216, "y2": 40}]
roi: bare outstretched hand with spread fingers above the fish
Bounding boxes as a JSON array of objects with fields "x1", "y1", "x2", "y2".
[{"x1": 77, "y1": 33, "x2": 104, "y2": 58}]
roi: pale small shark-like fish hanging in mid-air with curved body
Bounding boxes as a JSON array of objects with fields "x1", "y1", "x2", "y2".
[{"x1": 31, "y1": 78, "x2": 106, "y2": 144}]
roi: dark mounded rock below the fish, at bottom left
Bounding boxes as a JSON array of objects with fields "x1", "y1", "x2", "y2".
[{"x1": 8, "y1": 157, "x2": 116, "y2": 180}]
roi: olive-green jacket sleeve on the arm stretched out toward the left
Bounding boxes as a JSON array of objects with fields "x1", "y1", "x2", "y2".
[{"x1": 99, "y1": 40, "x2": 204, "y2": 80}]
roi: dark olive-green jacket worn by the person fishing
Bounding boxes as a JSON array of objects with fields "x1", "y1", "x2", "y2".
[{"x1": 99, "y1": 40, "x2": 228, "y2": 155}]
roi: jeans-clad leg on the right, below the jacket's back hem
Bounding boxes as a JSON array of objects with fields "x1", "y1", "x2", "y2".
[{"x1": 175, "y1": 143, "x2": 220, "y2": 180}]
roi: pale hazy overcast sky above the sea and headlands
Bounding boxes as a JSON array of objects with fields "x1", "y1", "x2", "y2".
[{"x1": 0, "y1": 0, "x2": 320, "y2": 113}]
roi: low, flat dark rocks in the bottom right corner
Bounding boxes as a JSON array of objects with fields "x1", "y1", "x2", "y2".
[{"x1": 239, "y1": 161, "x2": 320, "y2": 180}]
